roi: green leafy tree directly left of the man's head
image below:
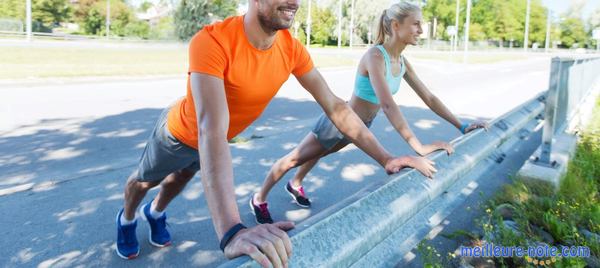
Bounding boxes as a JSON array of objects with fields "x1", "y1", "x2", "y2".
[{"x1": 174, "y1": 0, "x2": 238, "y2": 41}]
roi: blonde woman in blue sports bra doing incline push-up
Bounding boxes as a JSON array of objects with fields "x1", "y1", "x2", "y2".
[{"x1": 250, "y1": 2, "x2": 487, "y2": 223}]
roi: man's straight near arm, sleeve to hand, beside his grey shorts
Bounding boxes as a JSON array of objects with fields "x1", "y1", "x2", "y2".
[{"x1": 190, "y1": 73, "x2": 293, "y2": 267}]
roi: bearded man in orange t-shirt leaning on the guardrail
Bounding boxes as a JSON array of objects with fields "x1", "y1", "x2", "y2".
[{"x1": 117, "y1": 0, "x2": 434, "y2": 267}]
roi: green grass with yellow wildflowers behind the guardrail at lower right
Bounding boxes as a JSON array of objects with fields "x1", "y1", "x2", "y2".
[{"x1": 417, "y1": 98, "x2": 600, "y2": 267}]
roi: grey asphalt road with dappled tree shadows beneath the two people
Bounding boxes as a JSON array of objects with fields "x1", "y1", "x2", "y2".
[{"x1": 0, "y1": 53, "x2": 550, "y2": 267}]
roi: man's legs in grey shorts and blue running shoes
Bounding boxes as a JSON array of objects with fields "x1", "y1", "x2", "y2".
[{"x1": 117, "y1": 104, "x2": 199, "y2": 255}]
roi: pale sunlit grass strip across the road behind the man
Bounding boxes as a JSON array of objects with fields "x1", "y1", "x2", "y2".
[{"x1": 0, "y1": 46, "x2": 356, "y2": 79}]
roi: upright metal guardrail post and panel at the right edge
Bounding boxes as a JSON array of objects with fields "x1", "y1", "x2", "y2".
[{"x1": 535, "y1": 57, "x2": 600, "y2": 167}]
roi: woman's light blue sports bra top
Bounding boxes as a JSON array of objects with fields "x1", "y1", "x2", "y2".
[{"x1": 354, "y1": 45, "x2": 406, "y2": 104}]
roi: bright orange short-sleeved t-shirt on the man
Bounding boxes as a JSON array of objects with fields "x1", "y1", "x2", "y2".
[{"x1": 167, "y1": 16, "x2": 313, "y2": 148}]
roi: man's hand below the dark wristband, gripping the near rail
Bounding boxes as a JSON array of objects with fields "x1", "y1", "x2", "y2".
[{"x1": 225, "y1": 221, "x2": 294, "y2": 268}]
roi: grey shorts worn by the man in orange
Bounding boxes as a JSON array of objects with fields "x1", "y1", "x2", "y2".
[{"x1": 135, "y1": 107, "x2": 200, "y2": 182}]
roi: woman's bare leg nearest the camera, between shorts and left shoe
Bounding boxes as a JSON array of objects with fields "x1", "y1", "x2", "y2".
[{"x1": 255, "y1": 133, "x2": 326, "y2": 203}]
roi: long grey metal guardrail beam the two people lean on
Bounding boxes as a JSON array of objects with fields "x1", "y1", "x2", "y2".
[{"x1": 221, "y1": 93, "x2": 545, "y2": 267}]
